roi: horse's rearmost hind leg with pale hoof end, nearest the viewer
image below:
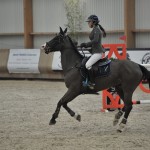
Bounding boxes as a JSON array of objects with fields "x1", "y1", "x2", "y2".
[{"x1": 117, "y1": 93, "x2": 133, "y2": 132}]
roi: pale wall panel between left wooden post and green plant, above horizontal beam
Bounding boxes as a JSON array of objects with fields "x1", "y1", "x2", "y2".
[{"x1": 33, "y1": 0, "x2": 66, "y2": 32}]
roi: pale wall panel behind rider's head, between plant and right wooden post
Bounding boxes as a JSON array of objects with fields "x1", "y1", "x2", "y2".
[{"x1": 82, "y1": 0, "x2": 124, "y2": 30}]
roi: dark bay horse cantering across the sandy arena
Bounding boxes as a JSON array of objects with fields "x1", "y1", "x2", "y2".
[{"x1": 42, "y1": 28, "x2": 150, "y2": 132}]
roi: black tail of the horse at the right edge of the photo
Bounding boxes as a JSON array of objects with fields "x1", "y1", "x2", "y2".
[{"x1": 139, "y1": 65, "x2": 150, "y2": 89}]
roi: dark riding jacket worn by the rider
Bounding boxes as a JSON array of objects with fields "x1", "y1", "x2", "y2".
[{"x1": 86, "y1": 25, "x2": 105, "y2": 54}]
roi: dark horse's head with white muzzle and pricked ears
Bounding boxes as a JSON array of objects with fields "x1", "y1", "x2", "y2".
[{"x1": 42, "y1": 27, "x2": 67, "y2": 54}]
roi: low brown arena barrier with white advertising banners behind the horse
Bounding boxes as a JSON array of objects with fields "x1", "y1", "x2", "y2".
[{"x1": 0, "y1": 49, "x2": 150, "y2": 79}]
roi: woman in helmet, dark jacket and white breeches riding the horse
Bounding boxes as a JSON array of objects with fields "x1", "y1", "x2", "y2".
[{"x1": 80, "y1": 15, "x2": 106, "y2": 87}]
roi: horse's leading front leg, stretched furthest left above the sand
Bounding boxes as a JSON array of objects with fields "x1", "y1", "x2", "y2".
[{"x1": 49, "y1": 89, "x2": 79, "y2": 125}]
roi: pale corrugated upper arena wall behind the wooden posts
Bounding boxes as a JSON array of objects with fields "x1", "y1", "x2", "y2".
[{"x1": 0, "y1": 0, "x2": 150, "y2": 49}]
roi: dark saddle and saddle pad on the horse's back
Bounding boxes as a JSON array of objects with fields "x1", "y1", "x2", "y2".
[{"x1": 81, "y1": 57, "x2": 111, "y2": 81}]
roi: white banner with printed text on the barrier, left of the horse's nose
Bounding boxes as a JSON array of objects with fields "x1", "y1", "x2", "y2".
[{"x1": 7, "y1": 49, "x2": 40, "y2": 73}]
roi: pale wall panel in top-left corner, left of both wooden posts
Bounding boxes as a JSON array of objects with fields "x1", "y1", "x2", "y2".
[{"x1": 0, "y1": 0, "x2": 24, "y2": 33}]
